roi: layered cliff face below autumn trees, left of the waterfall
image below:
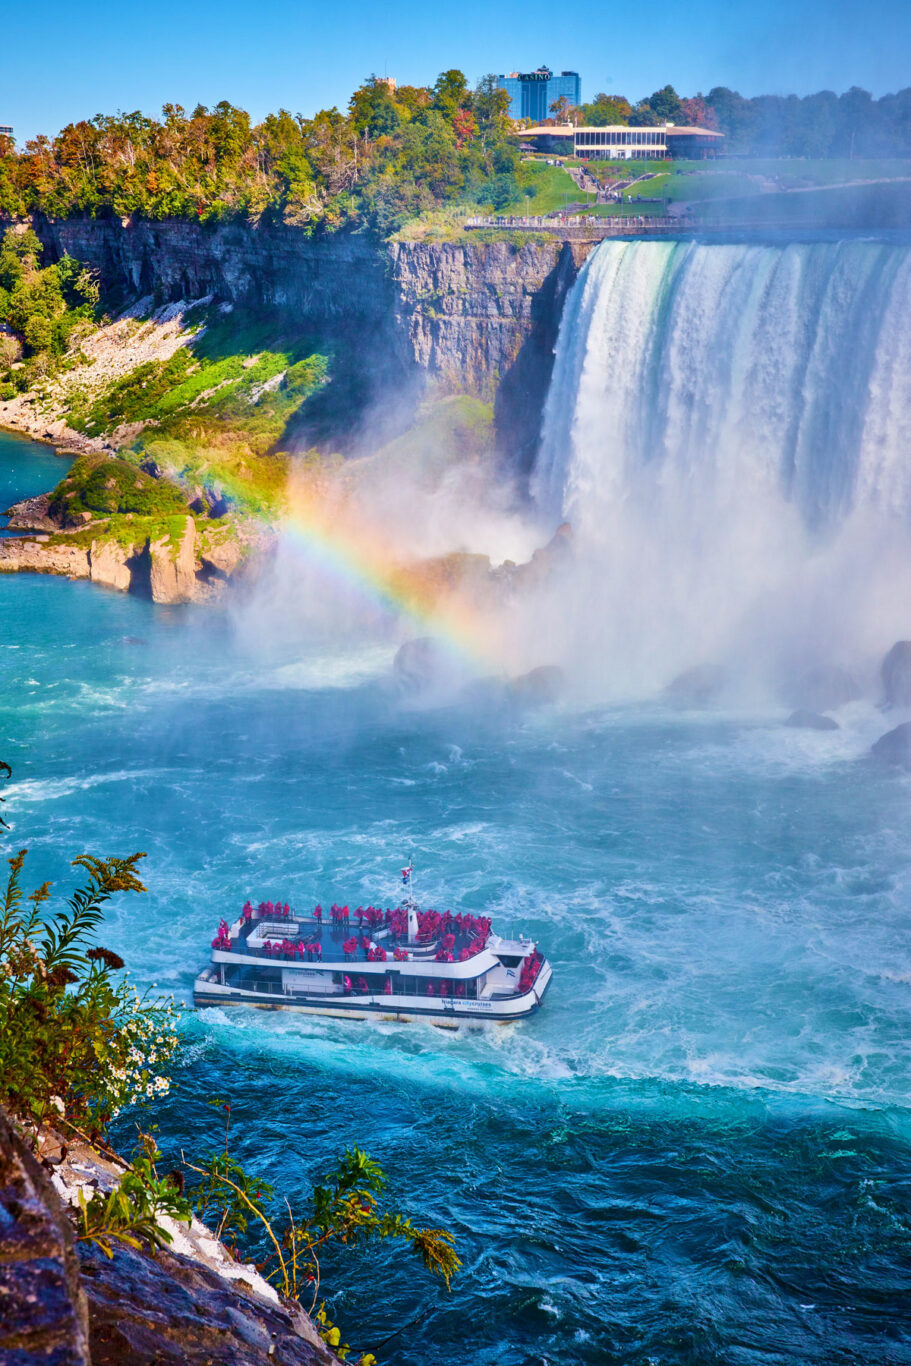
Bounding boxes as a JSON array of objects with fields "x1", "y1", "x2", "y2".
[{"x1": 36, "y1": 219, "x2": 594, "y2": 412}]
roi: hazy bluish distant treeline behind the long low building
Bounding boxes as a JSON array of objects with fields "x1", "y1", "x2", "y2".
[{"x1": 576, "y1": 85, "x2": 911, "y2": 157}]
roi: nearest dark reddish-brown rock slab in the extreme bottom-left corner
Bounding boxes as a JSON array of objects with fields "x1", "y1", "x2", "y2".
[{"x1": 0, "y1": 1111, "x2": 89, "y2": 1366}]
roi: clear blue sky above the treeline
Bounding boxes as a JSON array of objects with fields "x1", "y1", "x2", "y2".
[{"x1": 7, "y1": 0, "x2": 911, "y2": 143}]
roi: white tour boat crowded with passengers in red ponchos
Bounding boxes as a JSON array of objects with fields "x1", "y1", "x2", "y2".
[{"x1": 193, "y1": 863, "x2": 552, "y2": 1027}]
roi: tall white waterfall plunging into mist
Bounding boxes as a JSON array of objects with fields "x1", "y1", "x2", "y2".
[{"x1": 534, "y1": 239, "x2": 911, "y2": 690}]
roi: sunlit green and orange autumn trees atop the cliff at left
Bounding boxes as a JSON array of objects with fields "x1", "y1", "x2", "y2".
[{"x1": 0, "y1": 70, "x2": 519, "y2": 232}]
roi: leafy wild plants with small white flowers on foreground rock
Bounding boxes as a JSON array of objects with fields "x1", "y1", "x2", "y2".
[{"x1": 0, "y1": 762, "x2": 460, "y2": 1366}]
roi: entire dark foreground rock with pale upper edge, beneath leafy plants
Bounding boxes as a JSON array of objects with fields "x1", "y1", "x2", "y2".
[{"x1": 0, "y1": 1111, "x2": 339, "y2": 1366}]
